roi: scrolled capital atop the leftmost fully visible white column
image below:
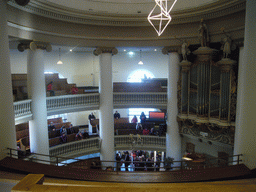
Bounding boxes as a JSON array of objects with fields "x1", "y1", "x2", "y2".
[{"x1": 18, "y1": 41, "x2": 52, "y2": 52}]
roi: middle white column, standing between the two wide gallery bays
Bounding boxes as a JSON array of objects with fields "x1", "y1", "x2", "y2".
[{"x1": 94, "y1": 47, "x2": 117, "y2": 169}]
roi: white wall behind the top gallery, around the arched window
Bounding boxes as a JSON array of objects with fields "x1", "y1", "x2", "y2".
[{"x1": 10, "y1": 50, "x2": 168, "y2": 86}]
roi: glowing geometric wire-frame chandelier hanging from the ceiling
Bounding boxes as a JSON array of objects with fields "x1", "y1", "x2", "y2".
[{"x1": 148, "y1": 0, "x2": 177, "y2": 36}]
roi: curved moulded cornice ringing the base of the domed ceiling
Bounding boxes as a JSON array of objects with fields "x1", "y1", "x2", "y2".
[{"x1": 8, "y1": 0, "x2": 246, "y2": 26}]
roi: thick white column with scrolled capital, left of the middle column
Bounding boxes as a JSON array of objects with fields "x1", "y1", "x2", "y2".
[{"x1": 18, "y1": 42, "x2": 51, "y2": 163}]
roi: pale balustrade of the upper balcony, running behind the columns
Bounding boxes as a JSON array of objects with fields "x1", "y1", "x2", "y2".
[{"x1": 14, "y1": 92, "x2": 167, "y2": 121}]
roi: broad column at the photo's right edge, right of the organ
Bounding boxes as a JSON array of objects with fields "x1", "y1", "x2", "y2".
[{"x1": 234, "y1": 0, "x2": 256, "y2": 169}]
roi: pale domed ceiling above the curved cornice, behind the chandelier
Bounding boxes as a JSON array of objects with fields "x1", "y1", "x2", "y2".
[{"x1": 42, "y1": 0, "x2": 218, "y2": 15}]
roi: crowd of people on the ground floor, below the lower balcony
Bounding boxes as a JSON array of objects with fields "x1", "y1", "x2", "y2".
[{"x1": 116, "y1": 150, "x2": 161, "y2": 171}]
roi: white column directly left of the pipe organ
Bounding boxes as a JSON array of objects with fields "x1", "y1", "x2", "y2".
[{"x1": 163, "y1": 47, "x2": 181, "y2": 166}]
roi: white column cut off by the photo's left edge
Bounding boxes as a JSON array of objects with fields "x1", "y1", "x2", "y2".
[{"x1": 0, "y1": 0, "x2": 17, "y2": 159}]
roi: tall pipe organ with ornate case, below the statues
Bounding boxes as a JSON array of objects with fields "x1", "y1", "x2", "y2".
[{"x1": 178, "y1": 47, "x2": 236, "y2": 145}]
